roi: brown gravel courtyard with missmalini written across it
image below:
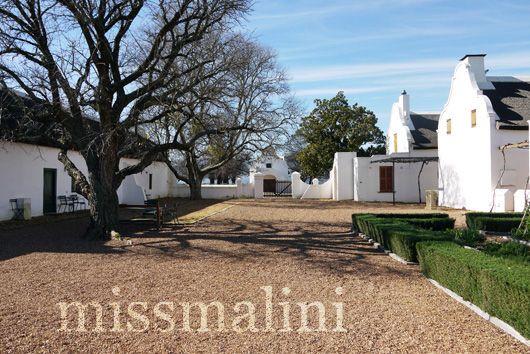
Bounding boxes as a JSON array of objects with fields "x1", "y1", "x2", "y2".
[{"x1": 0, "y1": 199, "x2": 528, "y2": 353}]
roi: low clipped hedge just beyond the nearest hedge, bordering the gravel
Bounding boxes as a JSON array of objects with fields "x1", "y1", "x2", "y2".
[{"x1": 353, "y1": 214, "x2": 454, "y2": 262}]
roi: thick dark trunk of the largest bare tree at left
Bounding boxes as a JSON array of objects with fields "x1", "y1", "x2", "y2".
[{"x1": 84, "y1": 151, "x2": 119, "y2": 240}]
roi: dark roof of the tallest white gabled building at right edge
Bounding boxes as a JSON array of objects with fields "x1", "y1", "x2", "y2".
[{"x1": 483, "y1": 81, "x2": 530, "y2": 130}]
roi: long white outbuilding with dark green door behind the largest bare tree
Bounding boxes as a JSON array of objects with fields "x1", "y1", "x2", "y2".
[{"x1": 0, "y1": 85, "x2": 176, "y2": 220}]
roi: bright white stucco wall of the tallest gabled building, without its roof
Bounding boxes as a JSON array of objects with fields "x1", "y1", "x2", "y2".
[{"x1": 438, "y1": 57, "x2": 528, "y2": 211}]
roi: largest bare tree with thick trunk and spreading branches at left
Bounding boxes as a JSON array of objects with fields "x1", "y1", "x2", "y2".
[{"x1": 0, "y1": 0, "x2": 249, "y2": 239}]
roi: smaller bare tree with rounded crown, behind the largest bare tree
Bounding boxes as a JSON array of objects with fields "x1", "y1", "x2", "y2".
[{"x1": 154, "y1": 35, "x2": 298, "y2": 199}]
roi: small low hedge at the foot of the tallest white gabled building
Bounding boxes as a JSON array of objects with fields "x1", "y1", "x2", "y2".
[{"x1": 466, "y1": 212, "x2": 523, "y2": 232}]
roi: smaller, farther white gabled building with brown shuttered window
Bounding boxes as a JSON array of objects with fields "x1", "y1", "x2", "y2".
[{"x1": 354, "y1": 91, "x2": 439, "y2": 202}]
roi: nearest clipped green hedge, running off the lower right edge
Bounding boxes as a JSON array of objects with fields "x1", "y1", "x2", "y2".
[{"x1": 416, "y1": 242, "x2": 530, "y2": 338}]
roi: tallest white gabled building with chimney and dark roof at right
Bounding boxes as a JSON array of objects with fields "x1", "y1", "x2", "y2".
[{"x1": 438, "y1": 54, "x2": 530, "y2": 211}]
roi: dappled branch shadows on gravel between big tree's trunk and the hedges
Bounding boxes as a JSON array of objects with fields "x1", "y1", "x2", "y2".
[{"x1": 120, "y1": 220, "x2": 408, "y2": 276}]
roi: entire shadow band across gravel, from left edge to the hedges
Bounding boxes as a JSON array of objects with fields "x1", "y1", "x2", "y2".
[{"x1": 0, "y1": 206, "x2": 414, "y2": 276}]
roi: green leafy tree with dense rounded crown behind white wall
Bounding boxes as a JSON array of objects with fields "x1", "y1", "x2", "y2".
[{"x1": 297, "y1": 92, "x2": 385, "y2": 178}]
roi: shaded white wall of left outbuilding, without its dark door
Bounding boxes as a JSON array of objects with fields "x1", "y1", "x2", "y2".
[{"x1": 0, "y1": 141, "x2": 172, "y2": 220}]
